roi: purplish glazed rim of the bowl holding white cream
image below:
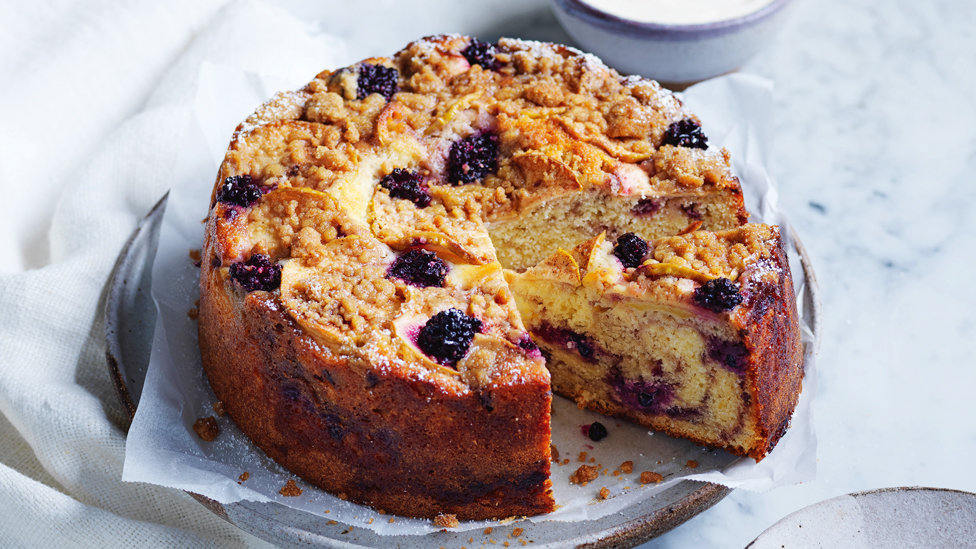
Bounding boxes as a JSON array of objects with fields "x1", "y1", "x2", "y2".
[{"x1": 551, "y1": 0, "x2": 792, "y2": 41}]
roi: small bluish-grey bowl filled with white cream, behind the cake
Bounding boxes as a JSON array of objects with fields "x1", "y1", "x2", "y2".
[{"x1": 549, "y1": 0, "x2": 791, "y2": 86}]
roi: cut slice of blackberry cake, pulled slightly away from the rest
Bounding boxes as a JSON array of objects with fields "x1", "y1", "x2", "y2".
[{"x1": 508, "y1": 225, "x2": 803, "y2": 461}]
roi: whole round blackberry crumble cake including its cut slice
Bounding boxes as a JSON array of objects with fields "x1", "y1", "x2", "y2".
[{"x1": 199, "y1": 35, "x2": 802, "y2": 519}]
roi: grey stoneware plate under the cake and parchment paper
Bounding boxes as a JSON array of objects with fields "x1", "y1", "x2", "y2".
[{"x1": 105, "y1": 196, "x2": 821, "y2": 549}]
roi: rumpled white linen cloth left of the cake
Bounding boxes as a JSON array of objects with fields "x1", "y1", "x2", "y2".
[{"x1": 0, "y1": 0, "x2": 346, "y2": 548}]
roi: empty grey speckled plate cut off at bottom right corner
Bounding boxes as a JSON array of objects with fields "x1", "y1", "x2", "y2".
[{"x1": 747, "y1": 487, "x2": 976, "y2": 549}]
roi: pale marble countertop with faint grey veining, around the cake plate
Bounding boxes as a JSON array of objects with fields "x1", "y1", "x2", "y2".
[{"x1": 0, "y1": 0, "x2": 976, "y2": 548}]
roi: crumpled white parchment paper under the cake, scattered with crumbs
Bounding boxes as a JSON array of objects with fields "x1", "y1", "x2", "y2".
[{"x1": 122, "y1": 58, "x2": 816, "y2": 535}]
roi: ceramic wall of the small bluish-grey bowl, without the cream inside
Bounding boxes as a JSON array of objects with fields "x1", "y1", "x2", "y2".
[{"x1": 549, "y1": 0, "x2": 791, "y2": 85}]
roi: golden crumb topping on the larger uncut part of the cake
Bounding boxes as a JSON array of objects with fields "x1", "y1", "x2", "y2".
[{"x1": 209, "y1": 35, "x2": 758, "y2": 392}]
